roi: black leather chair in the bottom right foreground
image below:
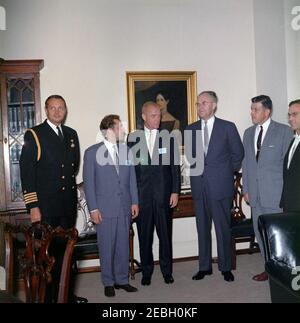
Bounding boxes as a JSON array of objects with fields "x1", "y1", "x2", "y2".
[{"x1": 258, "y1": 213, "x2": 300, "y2": 303}]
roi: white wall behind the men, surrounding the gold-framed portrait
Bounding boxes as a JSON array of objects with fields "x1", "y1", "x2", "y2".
[{"x1": 0, "y1": 0, "x2": 294, "y2": 264}]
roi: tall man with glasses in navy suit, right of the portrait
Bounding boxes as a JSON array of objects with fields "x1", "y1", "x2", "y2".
[{"x1": 187, "y1": 91, "x2": 244, "y2": 281}]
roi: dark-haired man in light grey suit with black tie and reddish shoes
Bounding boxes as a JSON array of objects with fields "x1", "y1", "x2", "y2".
[{"x1": 242, "y1": 95, "x2": 292, "y2": 281}]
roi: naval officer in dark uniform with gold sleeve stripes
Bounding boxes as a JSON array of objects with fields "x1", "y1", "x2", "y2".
[{"x1": 20, "y1": 95, "x2": 87, "y2": 302}]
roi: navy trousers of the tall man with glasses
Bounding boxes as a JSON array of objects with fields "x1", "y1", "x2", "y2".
[{"x1": 194, "y1": 189, "x2": 232, "y2": 271}]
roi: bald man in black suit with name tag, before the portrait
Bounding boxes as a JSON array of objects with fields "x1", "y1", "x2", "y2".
[{"x1": 128, "y1": 102, "x2": 180, "y2": 285}]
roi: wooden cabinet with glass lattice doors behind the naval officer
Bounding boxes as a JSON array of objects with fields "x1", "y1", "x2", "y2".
[{"x1": 0, "y1": 59, "x2": 44, "y2": 211}]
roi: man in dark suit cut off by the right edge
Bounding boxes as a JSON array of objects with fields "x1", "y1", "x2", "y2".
[{"x1": 280, "y1": 99, "x2": 300, "y2": 212}]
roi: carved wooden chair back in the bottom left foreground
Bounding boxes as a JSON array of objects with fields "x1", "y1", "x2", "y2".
[{"x1": 5, "y1": 223, "x2": 78, "y2": 303}]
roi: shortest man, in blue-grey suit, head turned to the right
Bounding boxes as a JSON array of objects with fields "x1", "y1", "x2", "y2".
[{"x1": 83, "y1": 115, "x2": 139, "y2": 297}]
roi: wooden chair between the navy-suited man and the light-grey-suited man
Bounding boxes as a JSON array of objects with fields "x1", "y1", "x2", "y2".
[{"x1": 231, "y1": 172, "x2": 259, "y2": 270}]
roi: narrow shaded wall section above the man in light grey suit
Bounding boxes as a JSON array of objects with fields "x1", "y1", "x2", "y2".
[{"x1": 253, "y1": 0, "x2": 288, "y2": 123}]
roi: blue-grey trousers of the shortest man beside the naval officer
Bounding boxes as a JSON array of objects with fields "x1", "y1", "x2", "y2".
[{"x1": 97, "y1": 216, "x2": 130, "y2": 286}]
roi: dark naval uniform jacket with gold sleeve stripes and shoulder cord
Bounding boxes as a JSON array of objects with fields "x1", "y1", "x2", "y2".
[{"x1": 20, "y1": 120, "x2": 80, "y2": 227}]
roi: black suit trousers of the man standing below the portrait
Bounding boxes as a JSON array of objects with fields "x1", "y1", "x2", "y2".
[{"x1": 136, "y1": 199, "x2": 173, "y2": 277}]
